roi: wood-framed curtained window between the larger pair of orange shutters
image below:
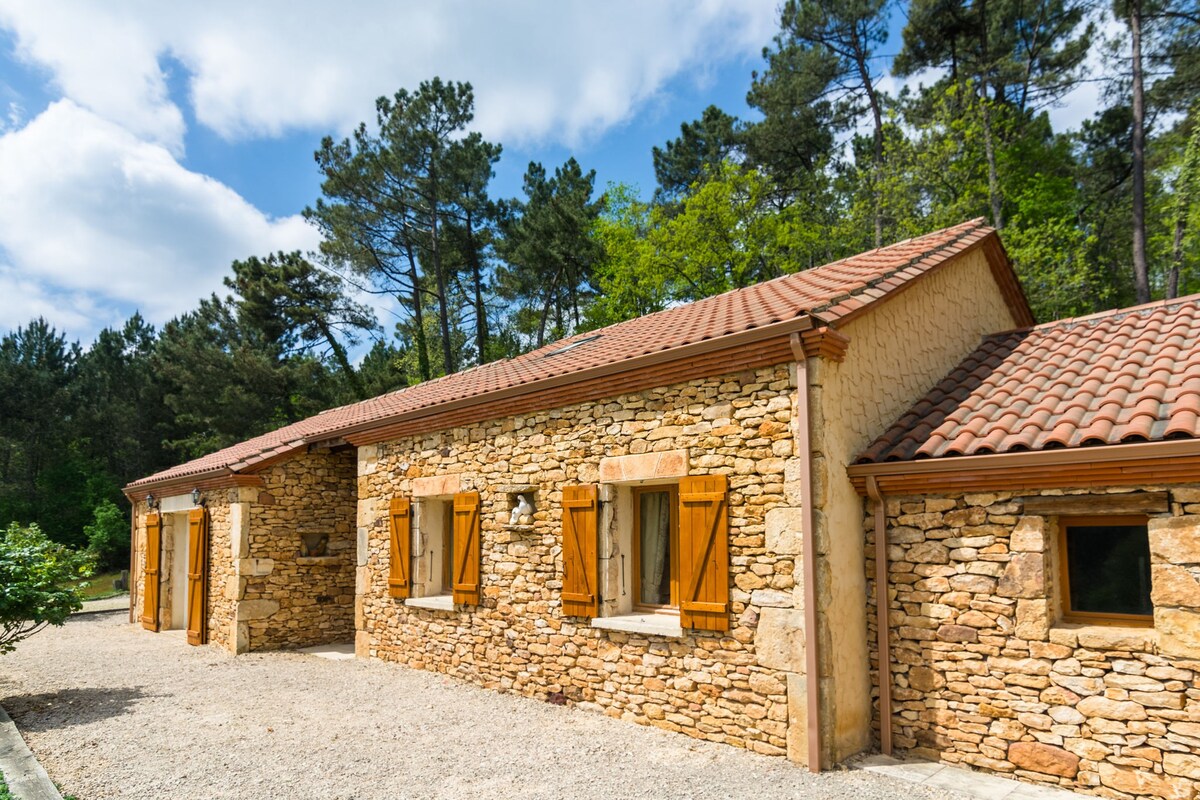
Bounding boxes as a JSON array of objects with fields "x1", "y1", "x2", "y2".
[{"x1": 634, "y1": 486, "x2": 679, "y2": 610}]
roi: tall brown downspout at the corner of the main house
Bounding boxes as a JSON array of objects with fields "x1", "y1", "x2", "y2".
[{"x1": 791, "y1": 333, "x2": 821, "y2": 772}]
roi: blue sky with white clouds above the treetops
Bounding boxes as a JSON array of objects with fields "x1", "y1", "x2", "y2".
[{"x1": 0, "y1": 0, "x2": 1086, "y2": 344}]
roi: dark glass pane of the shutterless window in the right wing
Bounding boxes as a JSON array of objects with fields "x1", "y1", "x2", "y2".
[{"x1": 1067, "y1": 525, "x2": 1154, "y2": 615}]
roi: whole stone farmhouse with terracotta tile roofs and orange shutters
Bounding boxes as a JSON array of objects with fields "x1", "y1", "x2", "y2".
[{"x1": 126, "y1": 219, "x2": 1200, "y2": 799}]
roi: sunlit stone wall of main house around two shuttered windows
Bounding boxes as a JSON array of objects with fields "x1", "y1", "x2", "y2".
[{"x1": 356, "y1": 366, "x2": 803, "y2": 754}]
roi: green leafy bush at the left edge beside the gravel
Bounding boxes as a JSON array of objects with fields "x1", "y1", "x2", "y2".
[{"x1": 0, "y1": 523, "x2": 94, "y2": 654}]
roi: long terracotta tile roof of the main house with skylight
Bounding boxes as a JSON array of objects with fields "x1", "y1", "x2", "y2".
[{"x1": 127, "y1": 218, "x2": 1017, "y2": 489}]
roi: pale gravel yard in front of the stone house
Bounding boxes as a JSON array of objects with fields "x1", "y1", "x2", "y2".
[{"x1": 0, "y1": 613, "x2": 966, "y2": 800}]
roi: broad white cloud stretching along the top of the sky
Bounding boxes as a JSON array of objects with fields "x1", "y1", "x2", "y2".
[{"x1": 0, "y1": 0, "x2": 778, "y2": 152}]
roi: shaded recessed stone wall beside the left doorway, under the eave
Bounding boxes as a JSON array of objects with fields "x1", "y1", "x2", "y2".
[{"x1": 238, "y1": 447, "x2": 358, "y2": 650}]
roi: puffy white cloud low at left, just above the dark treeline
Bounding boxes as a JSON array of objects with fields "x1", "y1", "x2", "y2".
[{"x1": 0, "y1": 101, "x2": 318, "y2": 341}]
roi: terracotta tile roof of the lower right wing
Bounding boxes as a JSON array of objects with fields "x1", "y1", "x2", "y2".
[{"x1": 858, "y1": 295, "x2": 1200, "y2": 464}]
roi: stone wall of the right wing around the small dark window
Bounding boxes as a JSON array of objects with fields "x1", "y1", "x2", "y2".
[{"x1": 864, "y1": 487, "x2": 1200, "y2": 800}]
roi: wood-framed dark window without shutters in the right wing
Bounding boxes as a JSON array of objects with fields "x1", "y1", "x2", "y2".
[{"x1": 1058, "y1": 516, "x2": 1154, "y2": 625}]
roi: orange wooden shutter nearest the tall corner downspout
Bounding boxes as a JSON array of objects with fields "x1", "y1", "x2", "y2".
[{"x1": 679, "y1": 475, "x2": 730, "y2": 631}]
